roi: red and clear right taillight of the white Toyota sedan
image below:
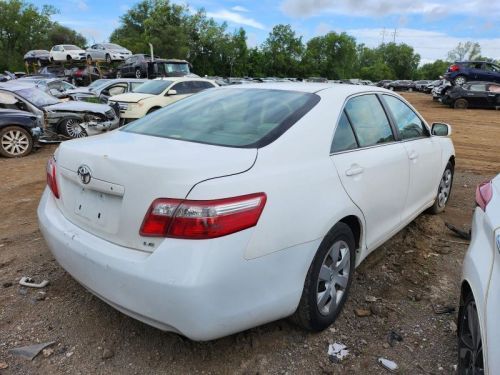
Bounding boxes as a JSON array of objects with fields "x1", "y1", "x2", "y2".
[{"x1": 140, "y1": 193, "x2": 266, "y2": 240}]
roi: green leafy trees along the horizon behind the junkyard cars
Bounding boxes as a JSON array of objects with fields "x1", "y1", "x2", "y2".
[{"x1": 0, "y1": 0, "x2": 498, "y2": 81}]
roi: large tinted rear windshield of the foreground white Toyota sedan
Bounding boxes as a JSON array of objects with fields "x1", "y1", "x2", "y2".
[{"x1": 122, "y1": 88, "x2": 319, "y2": 148}]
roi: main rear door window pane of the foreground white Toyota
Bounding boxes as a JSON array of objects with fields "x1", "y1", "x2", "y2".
[{"x1": 345, "y1": 95, "x2": 394, "y2": 147}]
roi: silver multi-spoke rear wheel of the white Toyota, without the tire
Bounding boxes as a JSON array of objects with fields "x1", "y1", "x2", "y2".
[{"x1": 316, "y1": 240, "x2": 351, "y2": 316}]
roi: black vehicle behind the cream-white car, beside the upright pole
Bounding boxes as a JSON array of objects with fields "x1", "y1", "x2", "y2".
[{"x1": 116, "y1": 54, "x2": 191, "y2": 78}]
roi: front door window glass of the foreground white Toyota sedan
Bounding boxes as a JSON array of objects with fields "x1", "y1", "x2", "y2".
[{"x1": 383, "y1": 95, "x2": 427, "y2": 139}]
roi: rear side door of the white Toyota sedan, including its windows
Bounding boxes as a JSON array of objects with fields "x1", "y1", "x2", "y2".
[{"x1": 331, "y1": 94, "x2": 409, "y2": 251}]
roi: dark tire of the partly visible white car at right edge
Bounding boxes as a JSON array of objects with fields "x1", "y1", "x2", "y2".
[{"x1": 458, "y1": 292, "x2": 484, "y2": 374}]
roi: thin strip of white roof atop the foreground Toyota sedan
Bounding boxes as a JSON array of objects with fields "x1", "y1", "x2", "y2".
[{"x1": 218, "y1": 82, "x2": 390, "y2": 95}]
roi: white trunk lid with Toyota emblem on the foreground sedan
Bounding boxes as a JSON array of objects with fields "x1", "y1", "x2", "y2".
[{"x1": 55, "y1": 131, "x2": 257, "y2": 251}]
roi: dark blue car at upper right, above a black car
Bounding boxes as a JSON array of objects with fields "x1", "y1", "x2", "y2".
[{"x1": 444, "y1": 61, "x2": 500, "y2": 86}]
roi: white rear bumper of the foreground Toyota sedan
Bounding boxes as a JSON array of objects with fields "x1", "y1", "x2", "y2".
[{"x1": 38, "y1": 189, "x2": 320, "y2": 340}]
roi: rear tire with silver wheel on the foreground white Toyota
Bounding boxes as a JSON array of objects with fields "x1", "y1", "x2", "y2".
[{"x1": 291, "y1": 223, "x2": 356, "y2": 332}]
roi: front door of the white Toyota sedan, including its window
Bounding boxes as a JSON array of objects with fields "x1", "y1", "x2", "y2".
[{"x1": 382, "y1": 95, "x2": 442, "y2": 220}]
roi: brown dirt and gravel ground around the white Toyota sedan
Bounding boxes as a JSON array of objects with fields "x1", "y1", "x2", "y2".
[{"x1": 0, "y1": 93, "x2": 500, "y2": 374}]
